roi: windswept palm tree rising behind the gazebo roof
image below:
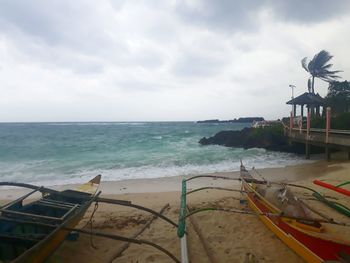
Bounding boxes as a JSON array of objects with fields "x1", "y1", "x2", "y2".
[{"x1": 301, "y1": 50, "x2": 342, "y2": 94}]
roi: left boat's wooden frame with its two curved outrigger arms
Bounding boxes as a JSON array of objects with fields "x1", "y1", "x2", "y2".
[{"x1": 0, "y1": 176, "x2": 180, "y2": 263}]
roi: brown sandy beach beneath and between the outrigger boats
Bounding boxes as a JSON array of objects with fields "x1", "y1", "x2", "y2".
[{"x1": 0, "y1": 161, "x2": 350, "y2": 263}]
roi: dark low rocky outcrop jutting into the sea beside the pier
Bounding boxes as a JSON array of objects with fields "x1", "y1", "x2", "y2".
[{"x1": 199, "y1": 125, "x2": 305, "y2": 154}]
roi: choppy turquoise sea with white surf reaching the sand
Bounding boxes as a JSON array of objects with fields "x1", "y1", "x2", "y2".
[{"x1": 0, "y1": 122, "x2": 304, "y2": 186}]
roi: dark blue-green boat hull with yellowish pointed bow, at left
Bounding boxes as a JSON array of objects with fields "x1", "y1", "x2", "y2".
[{"x1": 0, "y1": 175, "x2": 101, "y2": 263}]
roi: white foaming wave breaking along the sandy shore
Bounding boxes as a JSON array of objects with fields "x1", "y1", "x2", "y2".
[{"x1": 0, "y1": 153, "x2": 310, "y2": 189}]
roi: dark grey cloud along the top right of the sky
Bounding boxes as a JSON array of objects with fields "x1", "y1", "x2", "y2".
[{"x1": 177, "y1": 0, "x2": 350, "y2": 32}]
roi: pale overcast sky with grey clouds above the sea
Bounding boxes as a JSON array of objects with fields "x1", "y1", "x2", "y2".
[{"x1": 0, "y1": 0, "x2": 350, "y2": 122}]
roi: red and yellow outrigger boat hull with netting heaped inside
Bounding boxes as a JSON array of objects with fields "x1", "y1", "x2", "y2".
[{"x1": 240, "y1": 164, "x2": 350, "y2": 262}]
